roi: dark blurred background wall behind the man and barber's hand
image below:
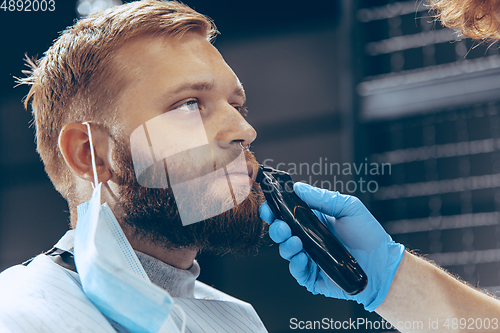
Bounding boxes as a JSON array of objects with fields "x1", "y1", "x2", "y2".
[{"x1": 0, "y1": 0, "x2": 500, "y2": 332}]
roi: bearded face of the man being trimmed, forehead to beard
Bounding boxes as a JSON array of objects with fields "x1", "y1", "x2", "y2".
[{"x1": 109, "y1": 33, "x2": 263, "y2": 252}]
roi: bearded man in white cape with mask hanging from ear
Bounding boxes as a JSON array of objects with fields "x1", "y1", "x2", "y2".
[{"x1": 0, "y1": 0, "x2": 266, "y2": 332}]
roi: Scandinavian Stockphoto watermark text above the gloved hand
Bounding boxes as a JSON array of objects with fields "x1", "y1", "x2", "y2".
[{"x1": 262, "y1": 157, "x2": 392, "y2": 194}]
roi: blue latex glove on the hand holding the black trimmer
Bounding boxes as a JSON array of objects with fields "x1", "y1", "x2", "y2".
[{"x1": 259, "y1": 183, "x2": 404, "y2": 312}]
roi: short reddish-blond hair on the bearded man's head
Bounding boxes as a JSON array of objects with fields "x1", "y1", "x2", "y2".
[{"x1": 19, "y1": 0, "x2": 216, "y2": 200}]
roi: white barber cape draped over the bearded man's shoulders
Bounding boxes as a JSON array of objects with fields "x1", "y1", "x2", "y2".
[{"x1": 0, "y1": 231, "x2": 267, "y2": 333}]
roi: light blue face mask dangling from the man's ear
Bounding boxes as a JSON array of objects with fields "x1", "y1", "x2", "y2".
[{"x1": 74, "y1": 123, "x2": 186, "y2": 332}]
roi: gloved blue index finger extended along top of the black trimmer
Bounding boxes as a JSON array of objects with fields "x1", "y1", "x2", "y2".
[{"x1": 293, "y1": 183, "x2": 367, "y2": 219}]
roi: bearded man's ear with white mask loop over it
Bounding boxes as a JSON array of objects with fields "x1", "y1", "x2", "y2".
[{"x1": 59, "y1": 123, "x2": 112, "y2": 182}]
